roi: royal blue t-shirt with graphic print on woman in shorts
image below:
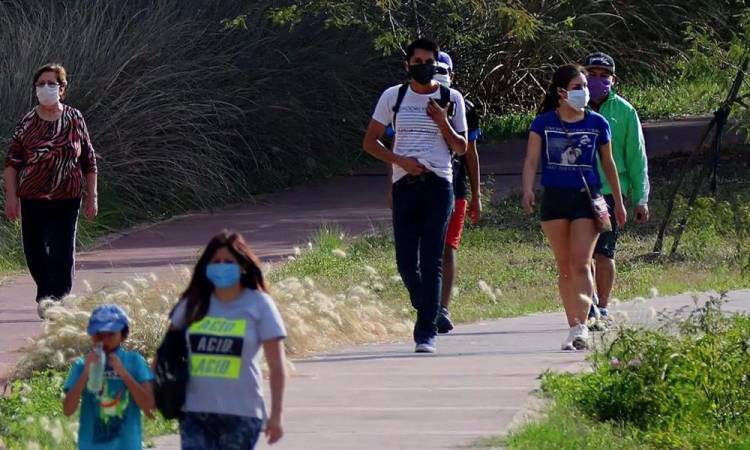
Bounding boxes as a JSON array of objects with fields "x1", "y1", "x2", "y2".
[{"x1": 530, "y1": 111, "x2": 611, "y2": 189}]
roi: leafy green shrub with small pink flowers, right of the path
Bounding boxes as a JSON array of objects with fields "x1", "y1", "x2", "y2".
[{"x1": 543, "y1": 298, "x2": 750, "y2": 449}]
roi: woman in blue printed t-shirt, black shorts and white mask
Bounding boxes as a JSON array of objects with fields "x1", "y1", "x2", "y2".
[{"x1": 523, "y1": 65, "x2": 627, "y2": 350}]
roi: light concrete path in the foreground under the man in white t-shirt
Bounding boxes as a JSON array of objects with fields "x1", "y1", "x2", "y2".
[{"x1": 151, "y1": 290, "x2": 750, "y2": 450}]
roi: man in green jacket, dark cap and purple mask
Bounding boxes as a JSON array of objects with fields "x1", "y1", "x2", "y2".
[{"x1": 584, "y1": 53, "x2": 650, "y2": 319}]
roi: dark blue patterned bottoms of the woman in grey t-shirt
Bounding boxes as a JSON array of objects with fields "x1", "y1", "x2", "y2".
[{"x1": 180, "y1": 412, "x2": 263, "y2": 450}]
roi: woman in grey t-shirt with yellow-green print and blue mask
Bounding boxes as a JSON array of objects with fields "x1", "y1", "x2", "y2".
[{"x1": 171, "y1": 232, "x2": 286, "y2": 450}]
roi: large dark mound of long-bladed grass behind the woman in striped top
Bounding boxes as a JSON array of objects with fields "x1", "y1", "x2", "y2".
[{"x1": 0, "y1": 0, "x2": 396, "y2": 221}]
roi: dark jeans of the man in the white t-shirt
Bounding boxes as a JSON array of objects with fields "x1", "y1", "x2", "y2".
[{"x1": 393, "y1": 173, "x2": 453, "y2": 343}]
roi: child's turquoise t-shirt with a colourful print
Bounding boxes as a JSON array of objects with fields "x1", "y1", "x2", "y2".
[{"x1": 63, "y1": 347, "x2": 154, "y2": 450}]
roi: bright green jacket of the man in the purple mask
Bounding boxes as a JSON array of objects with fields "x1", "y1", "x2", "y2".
[{"x1": 599, "y1": 90, "x2": 650, "y2": 205}]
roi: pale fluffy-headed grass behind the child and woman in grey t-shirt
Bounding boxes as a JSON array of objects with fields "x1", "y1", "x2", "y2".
[{"x1": 13, "y1": 268, "x2": 410, "y2": 378}]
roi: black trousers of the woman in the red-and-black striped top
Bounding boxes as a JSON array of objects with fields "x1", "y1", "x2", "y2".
[{"x1": 21, "y1": 199, "x2": 81, "y2": 302}]
